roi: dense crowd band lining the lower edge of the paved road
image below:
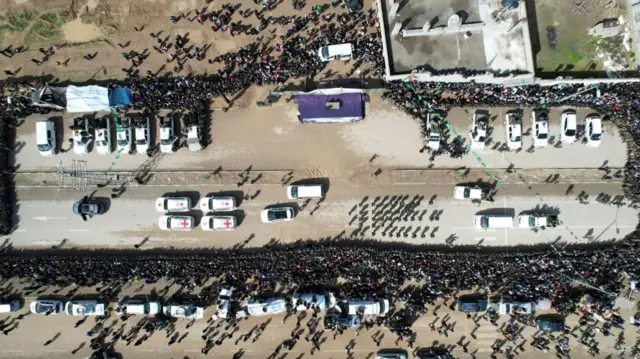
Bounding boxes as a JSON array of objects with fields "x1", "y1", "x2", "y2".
[{"x1": 0, "y1": 242, "x2": 640, "y2": 308}]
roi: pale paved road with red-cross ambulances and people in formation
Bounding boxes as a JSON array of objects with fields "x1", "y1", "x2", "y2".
[{"x1": 8, "y1": 184, "x2": 637, "y2": 247}]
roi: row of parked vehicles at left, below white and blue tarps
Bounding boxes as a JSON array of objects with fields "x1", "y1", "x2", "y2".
[{"x1": 36, "y1": 113, "x2": 203, "y2": 157}]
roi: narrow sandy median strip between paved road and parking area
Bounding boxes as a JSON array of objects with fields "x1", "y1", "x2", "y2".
[{"x1": 15, "y1": 168, "x2": 622, "y2": 188}]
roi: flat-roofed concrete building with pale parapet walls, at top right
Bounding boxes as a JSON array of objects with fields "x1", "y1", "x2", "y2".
[{"x1": 376, "y1": 0, "x2": 535, "y2": 85}]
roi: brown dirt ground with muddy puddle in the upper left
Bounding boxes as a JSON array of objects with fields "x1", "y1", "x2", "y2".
[{"x1": 0, "y1": 0, "x2": 378, "y2": 83}]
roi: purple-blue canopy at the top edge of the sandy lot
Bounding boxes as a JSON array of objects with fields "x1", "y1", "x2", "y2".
[{"x1": 294, "y1": 93, "x2": 364, "y2": 123}]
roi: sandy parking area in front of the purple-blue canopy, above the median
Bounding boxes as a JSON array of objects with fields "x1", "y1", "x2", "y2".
[{"x1": 15, "y1": 101, "x2": 626, "y2": 177}]
